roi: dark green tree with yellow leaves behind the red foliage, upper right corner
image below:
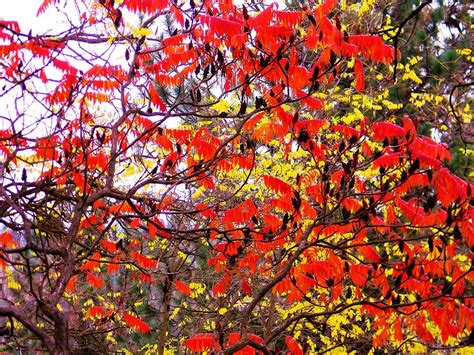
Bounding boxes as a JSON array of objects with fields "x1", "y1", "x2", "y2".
[{"x1": 349, "y1": 0, "x2": 473, "y2": 177}]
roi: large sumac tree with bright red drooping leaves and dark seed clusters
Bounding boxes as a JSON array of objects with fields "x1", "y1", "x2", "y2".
[{"x1": 0, "y1": 0, "x2": 474, "y2": 354}]
